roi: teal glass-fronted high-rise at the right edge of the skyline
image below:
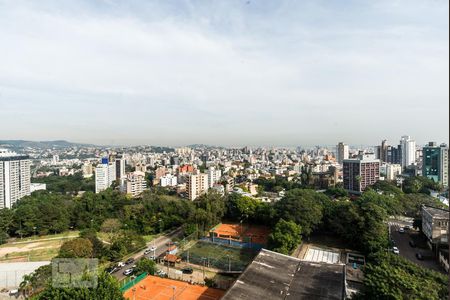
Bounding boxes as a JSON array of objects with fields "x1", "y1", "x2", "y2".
[{"x1": 422, "y1": 142, "x2": 449, "y2": 187}]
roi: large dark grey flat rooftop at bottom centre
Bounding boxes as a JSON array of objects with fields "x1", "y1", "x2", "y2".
[{"x1": 222, "y1": 249, "x2": 345, "y2": 300}]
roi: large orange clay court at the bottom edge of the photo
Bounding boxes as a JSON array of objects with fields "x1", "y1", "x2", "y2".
[{"x1": 124, "y1": 276, "x2": 225, "y2": 300}]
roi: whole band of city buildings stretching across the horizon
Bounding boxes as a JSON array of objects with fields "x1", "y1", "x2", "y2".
[{"x1": 0, "y1": 136, "x2": 449, "y2": 207}]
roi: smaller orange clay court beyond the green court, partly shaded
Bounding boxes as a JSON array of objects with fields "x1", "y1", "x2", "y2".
[{"x1": 211, "y1": 223, "x2": 270, "y2": 245}]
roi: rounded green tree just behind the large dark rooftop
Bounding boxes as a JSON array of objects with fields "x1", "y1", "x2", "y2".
[{"x1": 269, "y1": 219, "x2": 302, "y2": 255}]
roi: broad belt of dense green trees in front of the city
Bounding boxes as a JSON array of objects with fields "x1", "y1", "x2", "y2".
[{"x1": 0, "y1": 178, "x2": 445, "y2": 299}]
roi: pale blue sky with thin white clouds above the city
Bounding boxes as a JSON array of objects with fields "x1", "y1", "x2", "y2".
[{"x1": 0, "y1": 0, "x2": 449, "y2": 146}]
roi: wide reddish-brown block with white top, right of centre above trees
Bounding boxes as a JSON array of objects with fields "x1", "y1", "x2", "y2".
[{"x1": 343, "y1": 155, "x2": 380, "y2": 194}]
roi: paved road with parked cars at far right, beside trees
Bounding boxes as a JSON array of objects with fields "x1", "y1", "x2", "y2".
[{"x1": 389, "y1": 220, "x2": 443, "y2": 272}]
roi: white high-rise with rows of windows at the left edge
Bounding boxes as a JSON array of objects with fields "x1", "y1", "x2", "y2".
[{"x1": 0, "y1": 149, "x2": 31, "y2": 209}]
